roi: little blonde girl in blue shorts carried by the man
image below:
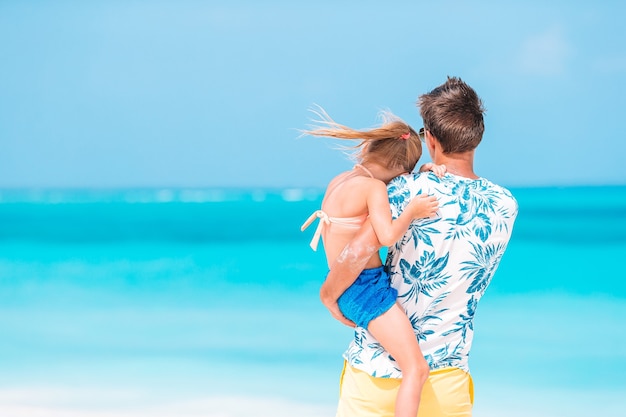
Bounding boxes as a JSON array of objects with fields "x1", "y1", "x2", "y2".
[{"x1": 301, "y1": 109, "x2": 445, "y2": 417}]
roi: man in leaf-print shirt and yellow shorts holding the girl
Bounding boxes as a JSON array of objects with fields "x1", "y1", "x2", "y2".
[{"x1": 320, "y1": 77, "x2": 518, "y2": 417}]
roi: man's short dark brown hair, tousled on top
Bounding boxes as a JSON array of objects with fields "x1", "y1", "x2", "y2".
[{"x1": 417, "y1": 77, "x2": 485, "y2": 153}]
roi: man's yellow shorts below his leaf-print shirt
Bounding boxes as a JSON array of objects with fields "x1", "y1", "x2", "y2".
[{"x1": 336, "y1": 362, "x2": 474, "y2": 417}]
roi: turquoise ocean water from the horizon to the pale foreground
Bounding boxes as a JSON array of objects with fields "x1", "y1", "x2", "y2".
[{"x1": 0, "y1": 186, "x2": 626, "y2": 417}]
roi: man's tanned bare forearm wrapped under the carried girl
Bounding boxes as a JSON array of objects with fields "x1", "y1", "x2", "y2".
[{"x1": 320, "y1": 220, "x2": 381, "y2": 327}]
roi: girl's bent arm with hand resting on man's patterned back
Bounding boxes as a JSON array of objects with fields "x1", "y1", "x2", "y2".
[{"x1": 367, "y1": 181, "x2": 439, "y2": 246}]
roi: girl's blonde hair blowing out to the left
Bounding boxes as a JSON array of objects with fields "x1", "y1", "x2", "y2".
[{"x1": 303, "y1": 107, "x2": 422, "y2": 172}]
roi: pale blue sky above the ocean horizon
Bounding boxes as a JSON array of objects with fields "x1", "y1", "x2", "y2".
[{"x1": 0, "y1": 0, "x2": 626, "y2": 187}]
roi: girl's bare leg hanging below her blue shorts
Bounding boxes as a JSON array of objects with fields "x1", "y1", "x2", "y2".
[{"x1": 367, "y1": 304, "x2": 429, "y2": 417}]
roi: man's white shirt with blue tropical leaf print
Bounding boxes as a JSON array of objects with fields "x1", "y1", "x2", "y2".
[{"x1": 344, "y1": 173, "x2": 518, "y2": 378}]
